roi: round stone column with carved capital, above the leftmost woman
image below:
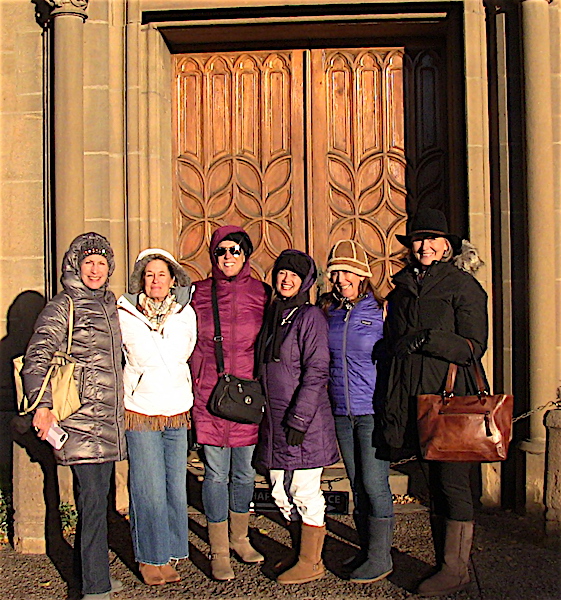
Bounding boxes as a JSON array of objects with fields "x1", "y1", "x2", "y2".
[{"x1": 48, "y1": 0, "x2": 88, "y2": 271}]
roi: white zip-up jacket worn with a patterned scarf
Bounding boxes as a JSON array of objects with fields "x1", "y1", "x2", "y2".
[{"x1": 117, "y1": 288, "x2": 197, "y2": 417}]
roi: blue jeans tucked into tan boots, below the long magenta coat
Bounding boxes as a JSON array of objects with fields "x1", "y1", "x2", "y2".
[{"x1": 203, "y1": 444, "x2": 255, "y2": 523}]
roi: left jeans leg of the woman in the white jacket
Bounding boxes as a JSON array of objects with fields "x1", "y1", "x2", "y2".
[{"x1": 126, "y1": 431, "x2": 170, "y2": 566}]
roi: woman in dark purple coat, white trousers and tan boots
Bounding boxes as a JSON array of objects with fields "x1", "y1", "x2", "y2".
[{"x1": 259, "y1": 250, "x2": 339, "y2": 583}]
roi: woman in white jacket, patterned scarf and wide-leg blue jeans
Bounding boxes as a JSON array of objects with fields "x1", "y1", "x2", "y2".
[{"x1": 117, "y1": 248, "x2": 197, "y2": 585}]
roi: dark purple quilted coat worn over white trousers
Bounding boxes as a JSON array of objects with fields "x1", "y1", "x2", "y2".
[{"x1": 258, "y1": 251, "x2": 339, "y2": 471}]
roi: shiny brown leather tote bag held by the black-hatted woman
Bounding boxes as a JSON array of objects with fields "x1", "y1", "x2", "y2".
[{"x1": 417, "y1": 344, "x2": 514, "y2": 462}]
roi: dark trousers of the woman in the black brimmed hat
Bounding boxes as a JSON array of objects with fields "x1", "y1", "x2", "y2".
[{"x1": 420, "y1": 460, "x2": 473, "y2": 521}]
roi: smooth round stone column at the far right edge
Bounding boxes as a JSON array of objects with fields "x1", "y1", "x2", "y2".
[{"x1": 520, "y1": 0, "x2": 557, "y2": 512}]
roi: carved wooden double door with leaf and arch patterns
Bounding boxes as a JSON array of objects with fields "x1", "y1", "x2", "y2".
[{"x1": 173, "y1": 47, "x2": 452, "y2": 291}]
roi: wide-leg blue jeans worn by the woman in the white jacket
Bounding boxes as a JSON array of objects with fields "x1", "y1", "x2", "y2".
[{"x1": 126, "y1": 427, "x2": 189, "y2": 565}]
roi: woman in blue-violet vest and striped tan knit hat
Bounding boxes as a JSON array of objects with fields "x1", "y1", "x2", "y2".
[{"x1": 320, "y1": 240, "x2": 394, "y2": 583}]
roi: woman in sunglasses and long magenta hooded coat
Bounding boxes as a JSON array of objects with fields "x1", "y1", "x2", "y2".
[{"x1": 191, "y1": 225, "x2": 269, "y2": 581}]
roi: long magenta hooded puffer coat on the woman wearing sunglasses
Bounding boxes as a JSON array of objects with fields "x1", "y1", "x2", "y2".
[{"x1": 190, "y1": 225, "x2": 269, "y2": 448}]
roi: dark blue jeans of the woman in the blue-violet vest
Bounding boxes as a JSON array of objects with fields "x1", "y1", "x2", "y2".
[{"x1": 335, "y1": 415, "x2": 393, "y2": 519}]
